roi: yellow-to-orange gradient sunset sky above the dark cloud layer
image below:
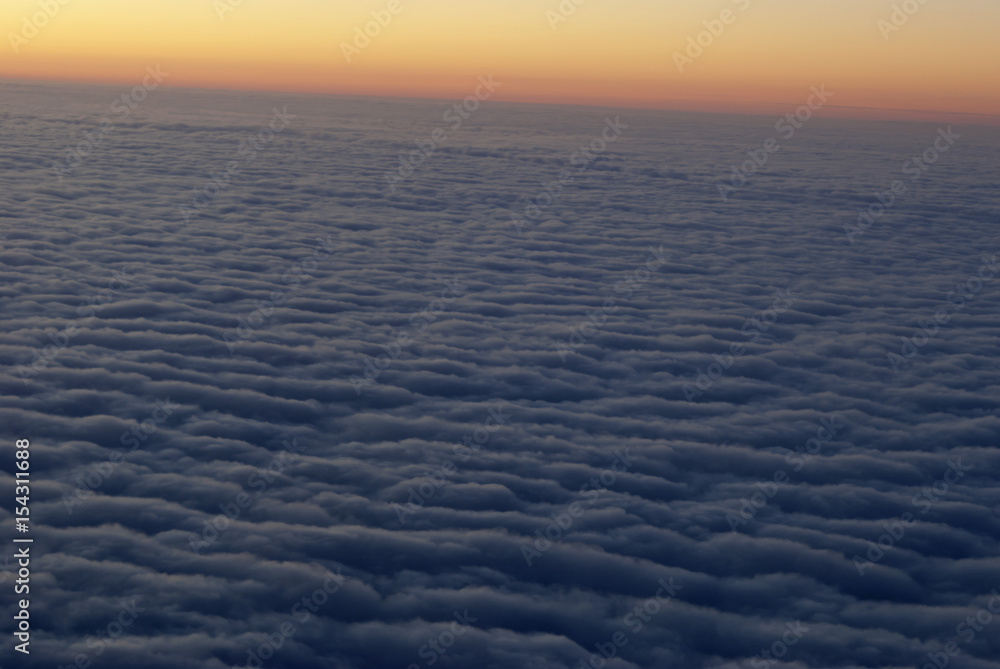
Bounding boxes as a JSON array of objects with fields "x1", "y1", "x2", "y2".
[{"x1": 0, "y1": 0, "x2": 1000, "y2": 117}]
